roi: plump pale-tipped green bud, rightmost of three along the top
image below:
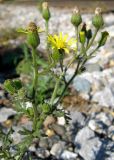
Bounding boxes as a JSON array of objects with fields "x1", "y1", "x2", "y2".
[{"x1": 92, "y1": 8, "x2": 104, "y2": 29}]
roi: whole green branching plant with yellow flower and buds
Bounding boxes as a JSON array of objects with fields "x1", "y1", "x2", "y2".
[{"x1": 0, "y1": 2, "x2": 108, "y2": 160}]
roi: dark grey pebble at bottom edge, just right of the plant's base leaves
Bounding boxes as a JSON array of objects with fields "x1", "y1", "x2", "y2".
[{"x1": 35, "y1": 148, "x2": 50, "y2": 158}]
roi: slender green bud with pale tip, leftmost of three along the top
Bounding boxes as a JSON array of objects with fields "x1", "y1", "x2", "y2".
[{"x1": 42, "y1": 2, "x2": 51, "y2": 21}]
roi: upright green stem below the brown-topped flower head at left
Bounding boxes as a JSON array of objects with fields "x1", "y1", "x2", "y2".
[{"x1": 32, "y1": 48, "x2": 38, "y2": 129}]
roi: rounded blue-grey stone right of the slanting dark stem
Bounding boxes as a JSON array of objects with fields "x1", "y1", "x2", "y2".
[{"x1": 73, "y1": 77, "x2": 91, "y2": 93}]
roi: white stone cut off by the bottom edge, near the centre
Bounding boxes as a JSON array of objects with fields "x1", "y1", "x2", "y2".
[{"x1": 60, "y1": 150, "x2": 77, "y2": 160}]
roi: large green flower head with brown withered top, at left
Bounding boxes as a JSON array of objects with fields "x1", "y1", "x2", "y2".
[{"x1": 27, "y1": 22, "x2": 40, "y2": 48}]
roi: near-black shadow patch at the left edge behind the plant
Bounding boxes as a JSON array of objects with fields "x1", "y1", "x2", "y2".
[{"x1": 0, "y1": 47, "x2": 23, "y2": 83}]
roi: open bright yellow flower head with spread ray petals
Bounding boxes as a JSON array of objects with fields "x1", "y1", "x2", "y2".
[{"x1": 48, "y1": 32, "x2": 76, "y2": 53}]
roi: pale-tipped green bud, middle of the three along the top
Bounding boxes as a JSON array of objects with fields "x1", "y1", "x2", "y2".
[{"x1": 71, "y1": 7, "x2": 82, "y2": 27}]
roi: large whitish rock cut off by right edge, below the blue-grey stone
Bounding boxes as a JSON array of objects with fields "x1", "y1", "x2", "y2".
[{"x1": 92, "y1": 87, "x2": 114, "y2": 108}]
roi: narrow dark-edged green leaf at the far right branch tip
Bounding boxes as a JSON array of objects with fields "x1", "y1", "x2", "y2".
[{"x1": 98, "y1": 31, "x2": 109, "y2": 48}]
